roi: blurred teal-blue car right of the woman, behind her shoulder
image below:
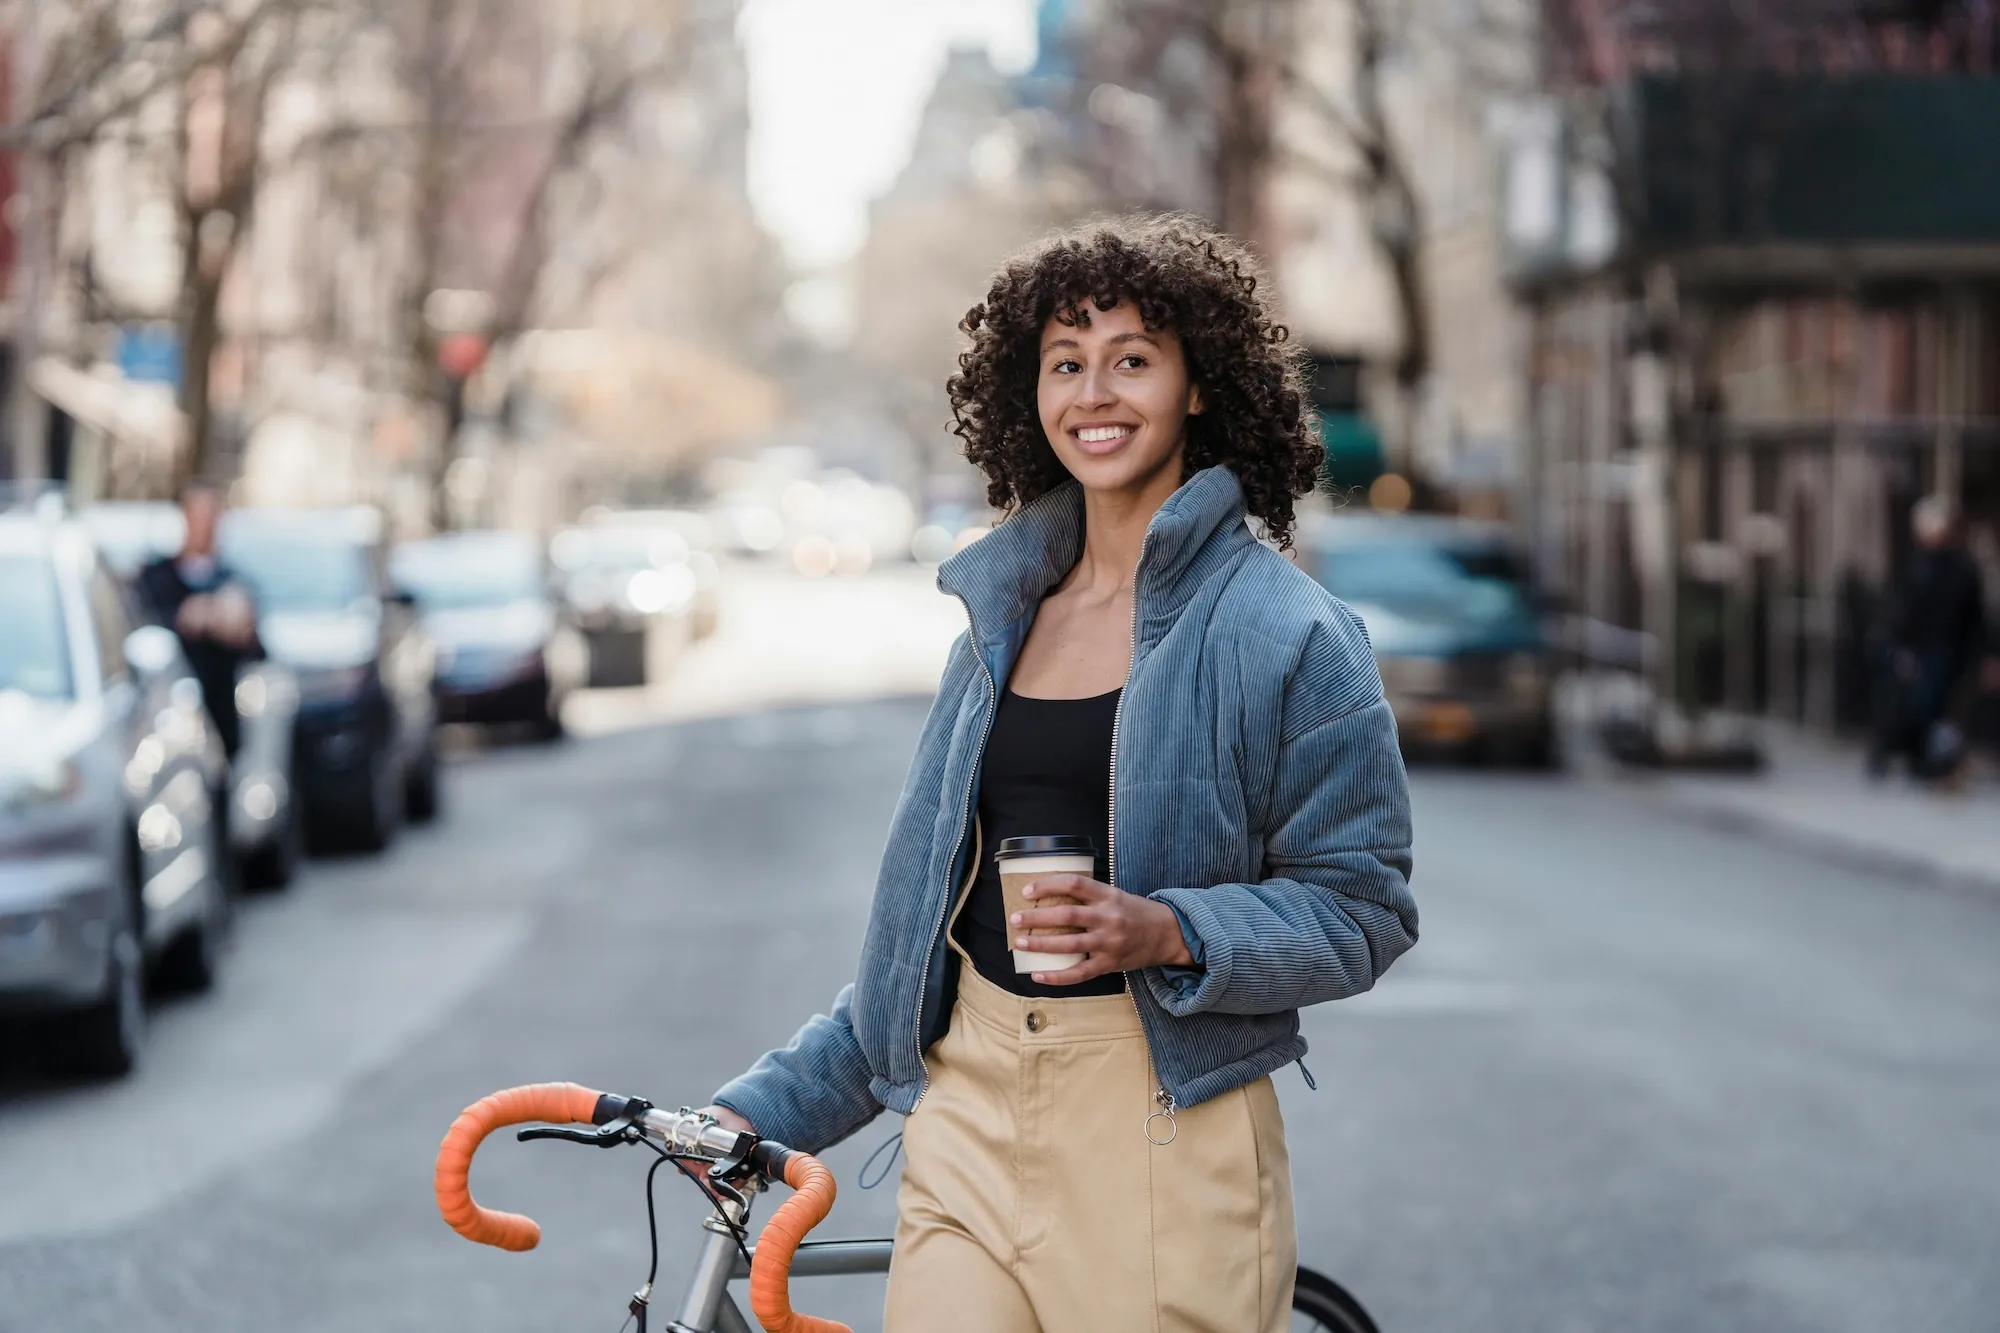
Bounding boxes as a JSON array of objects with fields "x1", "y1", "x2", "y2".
[{"x1": 1300, "y1": 514, "x2": 1556, "y2": 765}]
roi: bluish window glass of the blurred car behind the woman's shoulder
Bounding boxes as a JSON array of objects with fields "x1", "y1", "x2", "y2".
[{"x1": 1320, "y1": 540, "x2": 1530, "y2": 620}]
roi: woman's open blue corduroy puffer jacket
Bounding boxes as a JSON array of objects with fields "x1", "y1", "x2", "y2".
[{"x1": 716, "y1": 466, "x2": 1416, "y2": 1151}]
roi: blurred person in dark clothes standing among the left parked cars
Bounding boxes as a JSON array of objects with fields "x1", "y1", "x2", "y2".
[{"x1": 138, "y1": 480, "x2": 264, "y2": 757}]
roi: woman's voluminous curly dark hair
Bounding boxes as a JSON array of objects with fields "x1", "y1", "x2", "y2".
[{"x1": 946, "y1": 214, "x2": 1324, "y2": 546}]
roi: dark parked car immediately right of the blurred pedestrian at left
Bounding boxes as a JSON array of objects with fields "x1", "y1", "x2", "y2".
[{"x1": 222, "y1": 508, "x2": 438, "y2": 851}]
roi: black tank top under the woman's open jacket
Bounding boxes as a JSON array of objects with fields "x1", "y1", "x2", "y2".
[{"x1": 954, "y1": 691, "x2": 1124, "y2": 997}]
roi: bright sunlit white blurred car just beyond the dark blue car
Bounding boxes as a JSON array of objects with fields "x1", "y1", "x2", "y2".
[{"x1": 548, "y1": 524, "x2": 700, "y2": 685}]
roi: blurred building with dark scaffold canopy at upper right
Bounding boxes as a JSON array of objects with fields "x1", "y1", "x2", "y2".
[{"x1": 1508, "y1": 2, "x2": 2000, "y2": 729}]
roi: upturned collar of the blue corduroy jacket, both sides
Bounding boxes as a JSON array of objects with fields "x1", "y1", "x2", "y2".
[{"x1": 938, "y1": 466, "x2": 1256, "y2": 642}]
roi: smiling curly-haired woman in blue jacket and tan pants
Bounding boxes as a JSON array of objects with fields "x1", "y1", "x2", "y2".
[{"x1": 716, "y1": 218, "x2": 1416, "y2": 1333}]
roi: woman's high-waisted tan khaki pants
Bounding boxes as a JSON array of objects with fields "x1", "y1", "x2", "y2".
[{"x1": 884, "y1": 965, "x2": 1298, "y2": 1333}]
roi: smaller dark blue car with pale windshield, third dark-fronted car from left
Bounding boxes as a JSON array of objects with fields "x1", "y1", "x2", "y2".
[{"x1": 390, "y1": 532, "x2": 590, "y2": 739}]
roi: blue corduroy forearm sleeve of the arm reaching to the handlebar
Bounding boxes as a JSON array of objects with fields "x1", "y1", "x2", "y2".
[{"x1": 714, "y1": 985, "x2": 882, "y2": 1153}]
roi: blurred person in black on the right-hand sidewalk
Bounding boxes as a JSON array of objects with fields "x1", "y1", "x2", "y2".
[{"x1": 1868, "y1": 494, "x2": 1986, "y2": 779}]
